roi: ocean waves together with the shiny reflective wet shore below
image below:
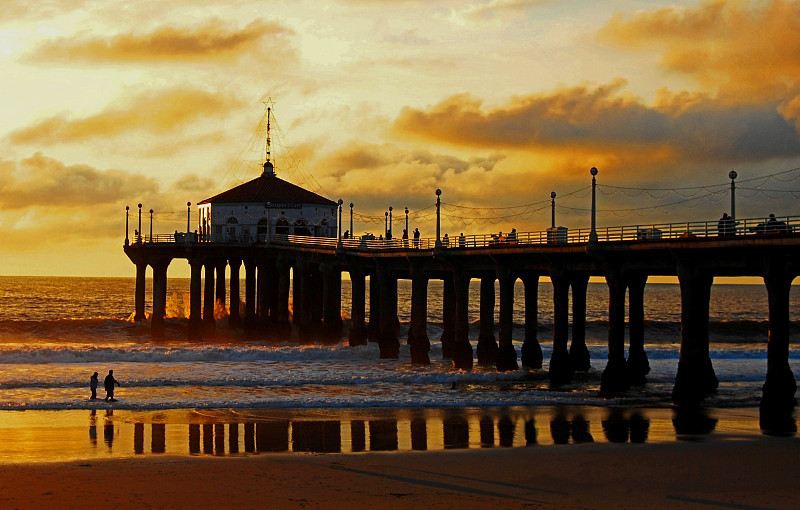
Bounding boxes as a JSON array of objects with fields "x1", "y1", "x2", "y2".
[{"x1": 0, "y1": 277, "x2": 800, "y2": 463}]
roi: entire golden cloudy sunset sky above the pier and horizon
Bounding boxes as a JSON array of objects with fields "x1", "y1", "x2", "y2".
[{"x1": 0, "y1": 0, "x2": 800, "y2": 276}]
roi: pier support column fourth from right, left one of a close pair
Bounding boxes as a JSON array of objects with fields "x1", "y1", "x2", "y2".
[{"x1": 600, "y1": 268, "x2": 629, "y2": 393}]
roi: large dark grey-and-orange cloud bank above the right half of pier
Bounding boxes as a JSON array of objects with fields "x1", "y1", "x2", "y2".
[{"x1": 394, "y1": 80, "x2": 800, "y2": 162}]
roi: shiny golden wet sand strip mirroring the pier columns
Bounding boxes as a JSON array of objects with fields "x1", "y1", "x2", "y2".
[{"x1": 0, "y1": 407, "x2": 780, "y2": 461}]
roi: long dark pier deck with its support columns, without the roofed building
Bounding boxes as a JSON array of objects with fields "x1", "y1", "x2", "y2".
[{"x1": 124, "y1": 209, "x2": 800, "y2": 415}]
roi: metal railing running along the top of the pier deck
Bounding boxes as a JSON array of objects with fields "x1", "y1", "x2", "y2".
[{"x1": 131, "y1": 216, "x2": 800, "y2": 251}]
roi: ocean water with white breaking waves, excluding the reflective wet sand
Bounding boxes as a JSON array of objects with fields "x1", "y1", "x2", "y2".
[{"x1": 0, "y1": 277, "x2": 800, "y2": 410}]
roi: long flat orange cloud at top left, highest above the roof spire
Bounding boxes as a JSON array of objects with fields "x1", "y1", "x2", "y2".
[{"x1": 27, "y1": 19, "x2": 295, "y2": 65}]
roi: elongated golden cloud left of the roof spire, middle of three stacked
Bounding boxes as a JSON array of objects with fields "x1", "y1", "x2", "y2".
[{"x1": 9, "y1": 87, "x2": 240, "y2": 144}]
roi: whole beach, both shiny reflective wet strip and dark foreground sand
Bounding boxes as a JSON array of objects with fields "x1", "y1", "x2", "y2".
[{"x1": 0, "y1": 407, "x2": 800, "y2": 510}]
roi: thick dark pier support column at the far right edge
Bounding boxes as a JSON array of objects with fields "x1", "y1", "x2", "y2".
[{"x1": 760, "y1": 264, "x2": 797, "y2": 434}]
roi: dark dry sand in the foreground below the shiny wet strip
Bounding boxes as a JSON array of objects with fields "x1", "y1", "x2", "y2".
[{"x1": 0, "y1": 436, "x2": 800, "y2": 510}]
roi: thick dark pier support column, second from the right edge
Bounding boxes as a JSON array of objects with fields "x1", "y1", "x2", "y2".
[{"x1": 672, "y1": 262, "x2": 719, "y2": 407}]
